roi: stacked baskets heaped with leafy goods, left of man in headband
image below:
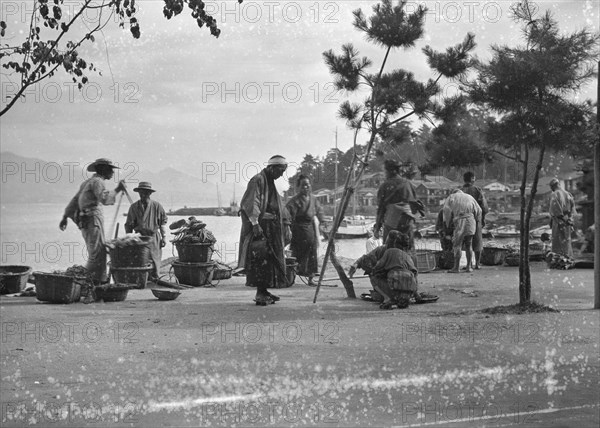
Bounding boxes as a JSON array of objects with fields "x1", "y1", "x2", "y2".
[{"x1": 169, "y1": 217, "x2": 217, "y2": 287}]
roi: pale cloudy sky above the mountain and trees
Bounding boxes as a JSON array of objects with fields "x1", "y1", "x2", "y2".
[{"x1": 0, "y1": 0, "x2": 599, "y2": 196}]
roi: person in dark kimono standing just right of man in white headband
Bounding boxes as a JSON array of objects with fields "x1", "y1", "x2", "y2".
[{"x1": 286, "y1": 175, "x2": 325, "y2": 287}]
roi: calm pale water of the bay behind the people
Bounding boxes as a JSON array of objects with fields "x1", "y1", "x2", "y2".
[{"x1": 0, "y1": 203, "x2": 446, "y2": 272}]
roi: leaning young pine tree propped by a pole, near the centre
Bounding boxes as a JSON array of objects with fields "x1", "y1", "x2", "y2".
[{"x1": 314, "y1": 0, "x2": 475, "y2": 301}]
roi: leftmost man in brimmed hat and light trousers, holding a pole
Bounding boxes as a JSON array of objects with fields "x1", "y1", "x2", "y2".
[{"x1": 59, "y1": 158, "x2": 125, "y2": 296}]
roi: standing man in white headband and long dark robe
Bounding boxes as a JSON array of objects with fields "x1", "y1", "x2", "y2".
[{"x1": 238, "y1": 155, "x2": 290, "y2": 306}]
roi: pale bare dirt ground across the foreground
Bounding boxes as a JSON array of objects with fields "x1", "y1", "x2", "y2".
[{"x1": 0, "y1": 263, "x2": 600, "y2": 427}]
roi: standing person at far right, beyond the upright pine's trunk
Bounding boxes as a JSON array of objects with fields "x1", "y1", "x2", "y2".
[{"x1": 549, "y1": 178, "x2": 575, "y2": 258}]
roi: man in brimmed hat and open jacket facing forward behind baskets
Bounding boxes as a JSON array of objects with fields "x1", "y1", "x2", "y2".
[{"x1": 125, "y1": 181, "x2": 167, "y2": 278}]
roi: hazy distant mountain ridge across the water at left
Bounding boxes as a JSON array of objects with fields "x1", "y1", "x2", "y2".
[{"x1": 0, "y1": 152, "x2": 244, "y2": 210}]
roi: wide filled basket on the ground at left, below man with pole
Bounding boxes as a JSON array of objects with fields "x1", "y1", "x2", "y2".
[{"x1": 34, "y1": 265, "x2": 92, "y2": 303}]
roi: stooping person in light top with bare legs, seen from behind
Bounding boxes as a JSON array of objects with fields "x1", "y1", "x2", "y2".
[{"x1": 442, "y1": 189, "x2": 481, "y2": 273}]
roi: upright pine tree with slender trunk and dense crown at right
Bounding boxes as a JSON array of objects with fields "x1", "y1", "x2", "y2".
[{"x1": 465, "y1": 0, "x2": 599, "y2": 304}]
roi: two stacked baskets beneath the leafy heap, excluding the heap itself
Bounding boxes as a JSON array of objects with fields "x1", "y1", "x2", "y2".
[{"x1": 171, "y1": 242, "x2": 216, "y2": 287}]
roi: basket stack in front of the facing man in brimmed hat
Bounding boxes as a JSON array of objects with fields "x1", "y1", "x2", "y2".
[{"x1": 110, "y1": 240, "x2": 152, "y2": 289}]
